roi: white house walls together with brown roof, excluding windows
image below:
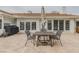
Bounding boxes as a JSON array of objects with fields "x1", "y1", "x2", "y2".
[{"x1": 0, "y1": 11, "x2": 79, "y2": 35}]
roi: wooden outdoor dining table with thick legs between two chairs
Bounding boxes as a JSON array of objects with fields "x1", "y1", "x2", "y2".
[{"x1": 34, "y1": 32, "x2": 55, "y2": 46}]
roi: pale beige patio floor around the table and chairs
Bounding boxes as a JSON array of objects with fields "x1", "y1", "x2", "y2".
[{"x1": 0, "y1": 33, "x2": 79, "y2": 53}]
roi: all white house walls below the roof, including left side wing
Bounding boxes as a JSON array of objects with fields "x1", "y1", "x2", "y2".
[{"x1": 0, "y1": 17, "x2": 76, "y2": 34}]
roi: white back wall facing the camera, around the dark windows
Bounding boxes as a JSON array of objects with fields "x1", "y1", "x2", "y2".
[{"x1": 17, "y1": 18, "x2": 75, "y2": 33}]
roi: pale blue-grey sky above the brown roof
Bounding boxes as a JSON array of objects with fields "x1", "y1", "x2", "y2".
[{"x1": 0, "y1": 6, "x2": 79, "y2": 14}]
